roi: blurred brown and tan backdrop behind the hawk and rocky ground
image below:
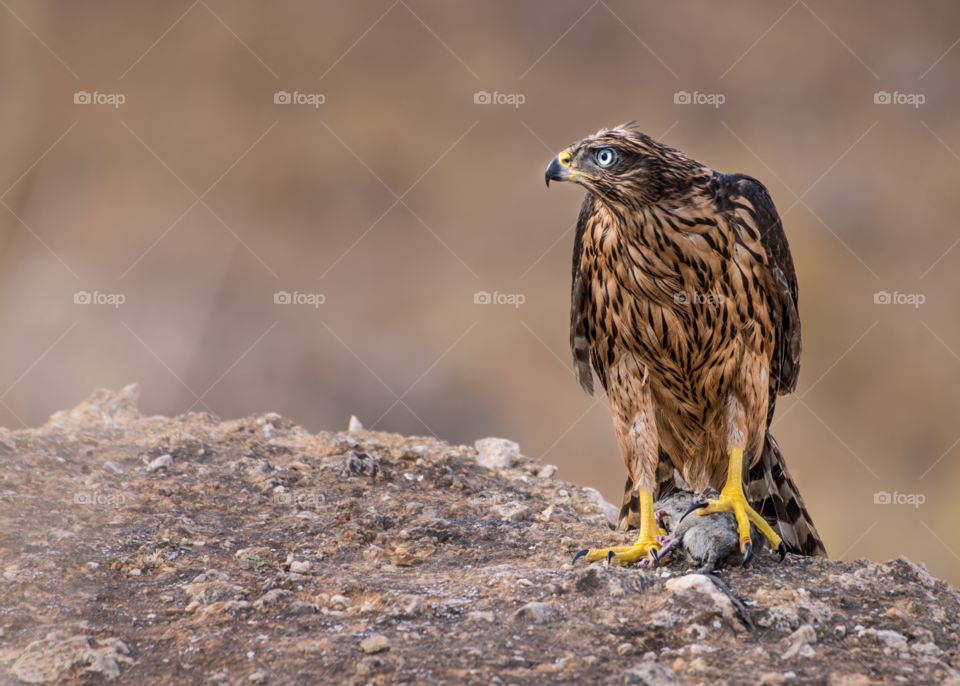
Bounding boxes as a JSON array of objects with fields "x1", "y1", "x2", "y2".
[{"x1": 0, "y1": 0, "x2": 960, "y2": 584}]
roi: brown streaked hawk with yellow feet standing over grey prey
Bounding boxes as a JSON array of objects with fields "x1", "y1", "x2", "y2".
[{"x1": 546, "y1": 122, "x2": 827, "y2": 565}]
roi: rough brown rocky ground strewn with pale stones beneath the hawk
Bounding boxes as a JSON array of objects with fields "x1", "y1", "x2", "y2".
[{"x1": 0, "y1": 386, "x2": 960, "y2": 686}]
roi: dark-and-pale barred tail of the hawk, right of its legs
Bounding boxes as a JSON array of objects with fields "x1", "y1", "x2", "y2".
[{"x1": 744, "y1": 432, "x2": 828, "y2": 557}]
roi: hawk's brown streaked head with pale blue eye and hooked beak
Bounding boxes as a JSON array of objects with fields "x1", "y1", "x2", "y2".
[{"x1": 547, "y1": 122, "x2": 709, "y2": 208}]
